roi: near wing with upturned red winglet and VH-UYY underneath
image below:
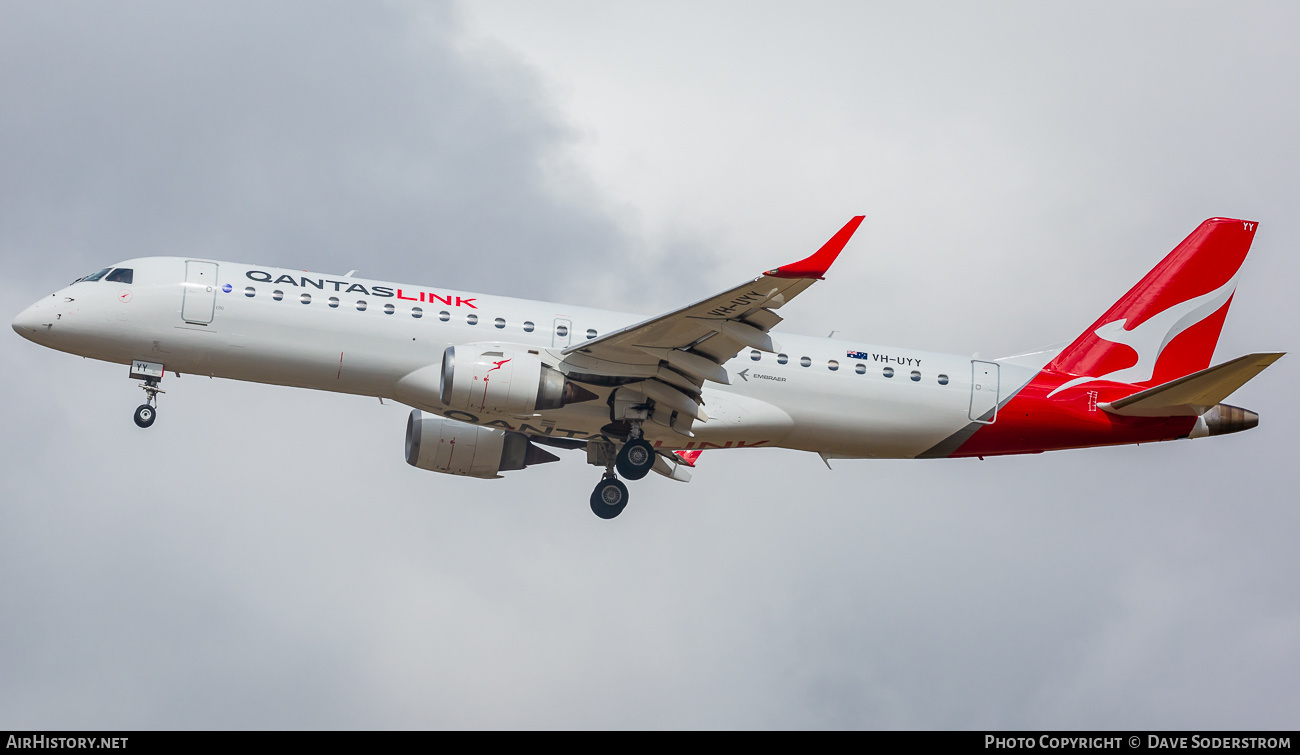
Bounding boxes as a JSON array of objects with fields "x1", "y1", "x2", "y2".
[{"x1": 563, "y1": 216, "x2": 862, "y2": 435}]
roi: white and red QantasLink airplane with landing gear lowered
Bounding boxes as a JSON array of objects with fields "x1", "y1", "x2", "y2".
[{"x1": 13, "y1": 216, "x2": 1283, "y2": 518}]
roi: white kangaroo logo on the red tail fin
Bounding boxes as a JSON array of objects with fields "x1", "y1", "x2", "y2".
[{"x1": 1048, "y1": 272, "x2": 1240, "y2": 399}]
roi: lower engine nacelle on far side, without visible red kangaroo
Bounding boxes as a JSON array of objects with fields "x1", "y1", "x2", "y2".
[{"x1": 406, "y1": 409, "x2": 559, "y2": 480}]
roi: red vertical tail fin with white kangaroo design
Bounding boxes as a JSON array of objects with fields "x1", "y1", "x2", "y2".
[{"x1": 1048, "y1": 217, "x2": 1258, "y2": 394}]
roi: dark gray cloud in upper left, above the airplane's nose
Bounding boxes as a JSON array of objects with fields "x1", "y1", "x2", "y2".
[{"x1": 0, "y1": 3, "x2": 624, "y2": 300}]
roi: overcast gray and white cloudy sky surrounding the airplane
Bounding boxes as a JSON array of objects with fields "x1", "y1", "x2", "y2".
[{"x1": 0, "y1": 0, "x2": 1300, "y2": 729}]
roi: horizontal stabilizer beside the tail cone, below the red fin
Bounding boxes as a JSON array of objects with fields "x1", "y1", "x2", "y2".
[{"x1": 1099, "y1": 352, "x2": 1284, "y2": 417}]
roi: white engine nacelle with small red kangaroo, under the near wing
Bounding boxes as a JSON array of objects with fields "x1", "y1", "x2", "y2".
[{"x1": 438, "y1": 343, "x2": 597, "y2": 415}]
